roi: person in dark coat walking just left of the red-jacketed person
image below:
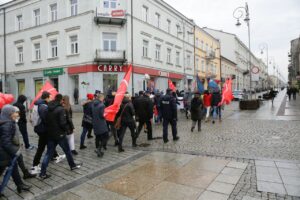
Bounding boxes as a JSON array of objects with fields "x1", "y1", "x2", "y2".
[{"x1": 191, "y1": 92, "x2": 203, "y2": 132}]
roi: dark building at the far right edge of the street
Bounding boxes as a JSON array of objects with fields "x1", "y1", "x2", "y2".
[{"x1": 288, "y1": 37, "x2": 300, "y2": 85}]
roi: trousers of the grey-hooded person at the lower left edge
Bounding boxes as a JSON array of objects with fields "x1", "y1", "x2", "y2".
[{"x1": 0, "y1": 158, "x2": 23, "y2": 194}]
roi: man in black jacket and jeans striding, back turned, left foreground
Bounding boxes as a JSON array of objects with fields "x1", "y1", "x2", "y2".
[{"x1": 40, "y1": 94, "x2": 81, "y2": 179}]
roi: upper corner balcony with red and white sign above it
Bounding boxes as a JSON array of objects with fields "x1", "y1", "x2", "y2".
[{"x1": 94, "y1": 10, "x2": 126, "y2": 26}]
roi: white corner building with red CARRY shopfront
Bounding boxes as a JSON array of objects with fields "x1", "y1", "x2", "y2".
[{"x1": 0, "y1": 0, "x2": 195, "y2": 103}]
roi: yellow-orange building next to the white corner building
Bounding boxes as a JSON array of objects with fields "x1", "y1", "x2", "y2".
[{"x1": 195, "y1": 26, "x2": 221, "y2": 88}]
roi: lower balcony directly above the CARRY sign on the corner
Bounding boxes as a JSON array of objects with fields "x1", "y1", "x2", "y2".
[{"x1": 94, "y1": 49, "x2": 127, "y2": 64}]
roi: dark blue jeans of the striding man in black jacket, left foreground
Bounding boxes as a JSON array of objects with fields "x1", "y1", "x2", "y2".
[{"x1": 40, "y1": 136, "x2": 76, "y2": 176}]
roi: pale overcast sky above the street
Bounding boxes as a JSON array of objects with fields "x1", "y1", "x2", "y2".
[{"x1": 0, "y1": 0, "x2": 300, "y2": 81}]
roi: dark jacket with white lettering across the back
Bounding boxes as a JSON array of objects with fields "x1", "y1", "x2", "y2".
[{"x1": 160, "y1": 94, "x2": 177, "y2": 120}]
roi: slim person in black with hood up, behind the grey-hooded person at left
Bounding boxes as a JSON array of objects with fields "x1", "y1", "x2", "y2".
[{"x1": 14, "y1": 95, "x2": 34, "y2": 150}]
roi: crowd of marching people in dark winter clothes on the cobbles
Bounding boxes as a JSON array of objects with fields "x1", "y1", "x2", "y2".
[{"x1": 0, "y1": 89, "x2": 222, "y2": 197}]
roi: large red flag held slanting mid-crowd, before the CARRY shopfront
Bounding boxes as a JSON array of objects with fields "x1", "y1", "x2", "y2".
[{"x1": 104, "y1": 65, "x2": 132, "y2": 122}]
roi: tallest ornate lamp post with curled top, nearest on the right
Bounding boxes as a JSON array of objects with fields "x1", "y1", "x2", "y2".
[{"x1": 233, "y1": 2, "x2": 252, "y2": 99}]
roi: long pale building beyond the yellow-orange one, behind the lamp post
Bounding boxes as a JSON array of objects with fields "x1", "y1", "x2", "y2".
[{"x1": 204, "y1": 27, "x2": 267, "y2": 91}]
